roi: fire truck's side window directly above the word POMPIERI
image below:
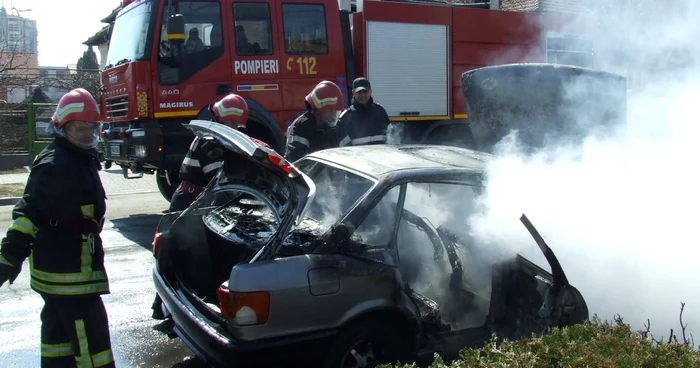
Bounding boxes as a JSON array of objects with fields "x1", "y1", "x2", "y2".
[{"x1": 233, "y1": 3, "x2": 273, "y2": 56}]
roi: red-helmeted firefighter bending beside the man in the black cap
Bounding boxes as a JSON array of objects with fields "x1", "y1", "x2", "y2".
[{"x1": 284, "y1": 81, "x2": 350, "y2": 162}]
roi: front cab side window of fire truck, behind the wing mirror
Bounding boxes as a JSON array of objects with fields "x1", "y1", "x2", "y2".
[{"x1": 159, "y1": 1, "x2": 224, "y2": 85}]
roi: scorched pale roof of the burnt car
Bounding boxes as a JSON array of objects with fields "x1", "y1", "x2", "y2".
[{"x1": 307, "y1": 144, "x2": 493, "y2": 177}]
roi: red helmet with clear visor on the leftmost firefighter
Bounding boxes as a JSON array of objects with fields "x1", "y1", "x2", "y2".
[{"x1": 51, "y1": 88, "x2": 102, "y2": 129}]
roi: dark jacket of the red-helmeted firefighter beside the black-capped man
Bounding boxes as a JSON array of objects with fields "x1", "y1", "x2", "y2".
[{"x1": 284, "y1": 111, "x2": 350, "y2": 162}]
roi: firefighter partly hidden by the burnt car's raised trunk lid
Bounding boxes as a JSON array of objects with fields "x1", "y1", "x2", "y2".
[{"x1": 170, "y1": 93, "x2": 248, "y2": 212}]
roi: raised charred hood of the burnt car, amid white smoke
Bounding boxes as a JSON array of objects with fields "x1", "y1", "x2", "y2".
[{"x1": 462, "y1": 64, "x2": 627, "y2": 152}]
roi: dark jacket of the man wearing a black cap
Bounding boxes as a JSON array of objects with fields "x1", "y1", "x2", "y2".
[{"x1": 339, "y1": 97, "x2": 389, "y2": 146}]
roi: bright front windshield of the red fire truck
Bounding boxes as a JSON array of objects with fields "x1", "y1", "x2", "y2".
[{"x1": 107, "y1": 0, "x2": 154, "y2": 66}]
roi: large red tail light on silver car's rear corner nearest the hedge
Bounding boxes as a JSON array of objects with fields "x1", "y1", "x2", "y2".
[{"x1": 216, "y1": 287, "x2": 270, "y2": 326}]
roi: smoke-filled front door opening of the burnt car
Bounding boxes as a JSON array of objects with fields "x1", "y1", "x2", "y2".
[{"x1": 397, "y1": 182, "x2": 493, "y2": 328}]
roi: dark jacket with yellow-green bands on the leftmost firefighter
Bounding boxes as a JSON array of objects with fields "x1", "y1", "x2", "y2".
[{"x1": 0, "y1": 137, "x2": 109, "y2": 296}]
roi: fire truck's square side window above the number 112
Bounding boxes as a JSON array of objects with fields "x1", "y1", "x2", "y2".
[{"x1": 282, "y1": 4, "x2": 328, "y2": 54}]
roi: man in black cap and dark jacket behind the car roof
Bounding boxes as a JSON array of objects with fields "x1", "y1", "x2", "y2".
[{"x1": 340, "y1": 77, "x2": 389, "y2": 146}]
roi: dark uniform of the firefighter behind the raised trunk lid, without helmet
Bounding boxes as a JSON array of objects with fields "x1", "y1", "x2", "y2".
[{"x1": 170, "y1": 136, "x2": 224, "y2": 211}]
